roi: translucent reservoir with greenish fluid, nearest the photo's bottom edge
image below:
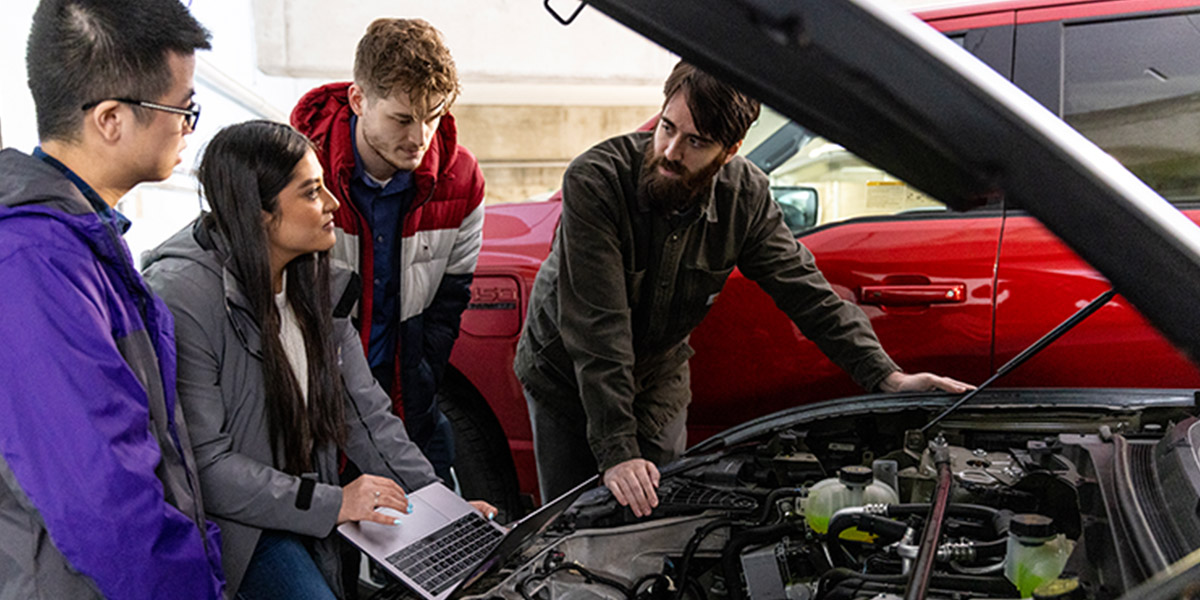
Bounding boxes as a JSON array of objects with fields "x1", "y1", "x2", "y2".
[{"x1": 1004, "y1": 514, "x2": 1073, "y2": 598}]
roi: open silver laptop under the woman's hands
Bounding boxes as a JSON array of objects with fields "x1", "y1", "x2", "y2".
[{"x1": 337, "y1": 478, "x2": 595, "y2": 600}]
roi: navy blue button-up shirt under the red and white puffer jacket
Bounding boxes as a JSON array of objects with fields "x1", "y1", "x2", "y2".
[{"x1": 350, "y1": 116, "x2": 415, "y2": 370}]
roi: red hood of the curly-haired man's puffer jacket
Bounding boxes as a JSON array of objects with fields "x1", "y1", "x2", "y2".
[{"x1": 292, "y1": 82, "x2": 458, "y2": 190}]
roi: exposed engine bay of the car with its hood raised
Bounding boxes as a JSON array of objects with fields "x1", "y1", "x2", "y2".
[{"x1": 456, "y1": 393, "x2": 1200, "y2": 600}]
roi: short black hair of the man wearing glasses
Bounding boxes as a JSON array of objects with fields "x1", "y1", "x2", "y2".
[{"x1": 25, "y1": 0, "x2": 210, "y2": 140}]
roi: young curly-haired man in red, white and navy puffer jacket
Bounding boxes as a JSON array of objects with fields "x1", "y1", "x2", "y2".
[{"x1": 292, "y1": 18, "x2": 484, "y2": 481}]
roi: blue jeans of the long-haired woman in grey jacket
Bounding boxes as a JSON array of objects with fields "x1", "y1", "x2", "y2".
[{"x1": 238, "y1": 529, "x2": 336, "y2": 600}]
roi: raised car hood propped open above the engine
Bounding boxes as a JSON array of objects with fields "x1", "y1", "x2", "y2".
[{"x1": 580, "y1": 0, "x2": 1200, "y2": 369}]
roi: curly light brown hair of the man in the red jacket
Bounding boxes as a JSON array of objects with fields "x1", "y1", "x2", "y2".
[{"x1": 354, "y1": 18, "x2": 460, "y2": 113}]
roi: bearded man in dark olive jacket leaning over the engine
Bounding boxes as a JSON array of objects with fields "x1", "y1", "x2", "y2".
[{"x1": 514, "y1": 62, "x2": 970, "y2": 517}]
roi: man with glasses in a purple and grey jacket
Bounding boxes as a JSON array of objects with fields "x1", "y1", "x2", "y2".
[{"x1": 0, "y1": 0, "x2": 224, "y2": 599}]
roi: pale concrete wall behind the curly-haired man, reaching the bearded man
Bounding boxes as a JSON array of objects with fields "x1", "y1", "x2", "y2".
[{"x1": 243, "y1": 0, "x2": 964, "y2": 203}]
